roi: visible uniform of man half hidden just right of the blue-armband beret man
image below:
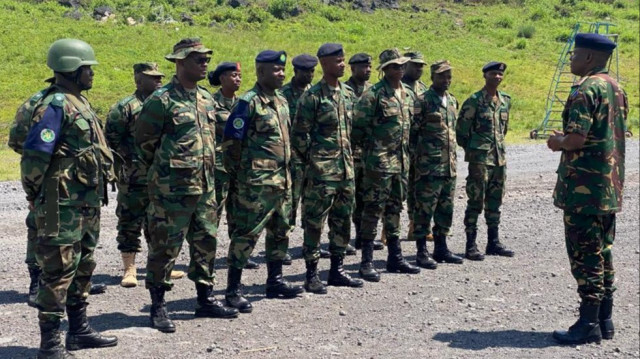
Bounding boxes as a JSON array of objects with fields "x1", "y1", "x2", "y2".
[{"x1": 279, "y1": 82, "x2": 311, "y2": 227}]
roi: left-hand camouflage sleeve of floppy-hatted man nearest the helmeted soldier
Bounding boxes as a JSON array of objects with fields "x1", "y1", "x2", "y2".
[{"x1": 134, "y1": 95, "x2": 165, "y2": 173}]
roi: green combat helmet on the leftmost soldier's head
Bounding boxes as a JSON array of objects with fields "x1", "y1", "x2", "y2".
[{"x1": 47, "y1": 39, "x2": 98, "y2": 72}]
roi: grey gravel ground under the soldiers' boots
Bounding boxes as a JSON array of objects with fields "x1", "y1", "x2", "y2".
[{"x1": 0, "y1": 139, "x2": 640, "y2": 358}]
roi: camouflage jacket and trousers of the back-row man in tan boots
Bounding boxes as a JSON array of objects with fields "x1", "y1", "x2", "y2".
[{"x1": 105, "y1": 91, "x2": 149, "y2": 253}]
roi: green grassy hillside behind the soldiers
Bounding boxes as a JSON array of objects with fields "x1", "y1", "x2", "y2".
[{"x1": 0, "y1": 0, "x2": 640, "y2": 180}]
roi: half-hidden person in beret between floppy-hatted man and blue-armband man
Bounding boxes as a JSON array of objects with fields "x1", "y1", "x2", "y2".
[{"x1": 207, "y1": 62, "x2": 260, "y2": 269}]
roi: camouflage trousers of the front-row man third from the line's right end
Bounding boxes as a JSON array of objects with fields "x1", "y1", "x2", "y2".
[{"x1": 360, "y1": 170, "x2": 407, "y2": 241}]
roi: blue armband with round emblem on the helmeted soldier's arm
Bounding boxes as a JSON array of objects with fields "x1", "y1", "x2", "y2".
[{"x1": 24, "y1": 104, "x2": 63, "y2": 154}]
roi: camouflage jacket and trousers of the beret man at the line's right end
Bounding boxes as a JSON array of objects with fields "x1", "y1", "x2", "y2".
[{"x1": 456, "y1": 89, "x2": 511, "y2": 233}]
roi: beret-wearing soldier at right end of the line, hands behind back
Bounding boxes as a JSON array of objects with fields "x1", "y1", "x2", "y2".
[{"x1": 456, "y1": 61, "x2": 514, "y2": 261}]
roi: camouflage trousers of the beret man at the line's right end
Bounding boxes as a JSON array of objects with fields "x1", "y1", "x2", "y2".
[{"x1": 464, "y1": 163, "x2": 507, "y2": 232}]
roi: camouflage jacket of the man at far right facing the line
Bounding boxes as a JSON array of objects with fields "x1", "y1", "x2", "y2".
[{"x1": 553, "y1": 68, "x2": 629, "y2": 215}]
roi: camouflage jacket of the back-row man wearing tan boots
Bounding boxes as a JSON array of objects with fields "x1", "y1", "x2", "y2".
[{"x1": 105, "y1": 91, "x2": 147, "y2": 185}]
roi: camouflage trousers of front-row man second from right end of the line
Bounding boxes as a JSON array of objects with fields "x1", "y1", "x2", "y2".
[{"x1": 413, "y1": 175, "x2": 456, "y2": 238}]
